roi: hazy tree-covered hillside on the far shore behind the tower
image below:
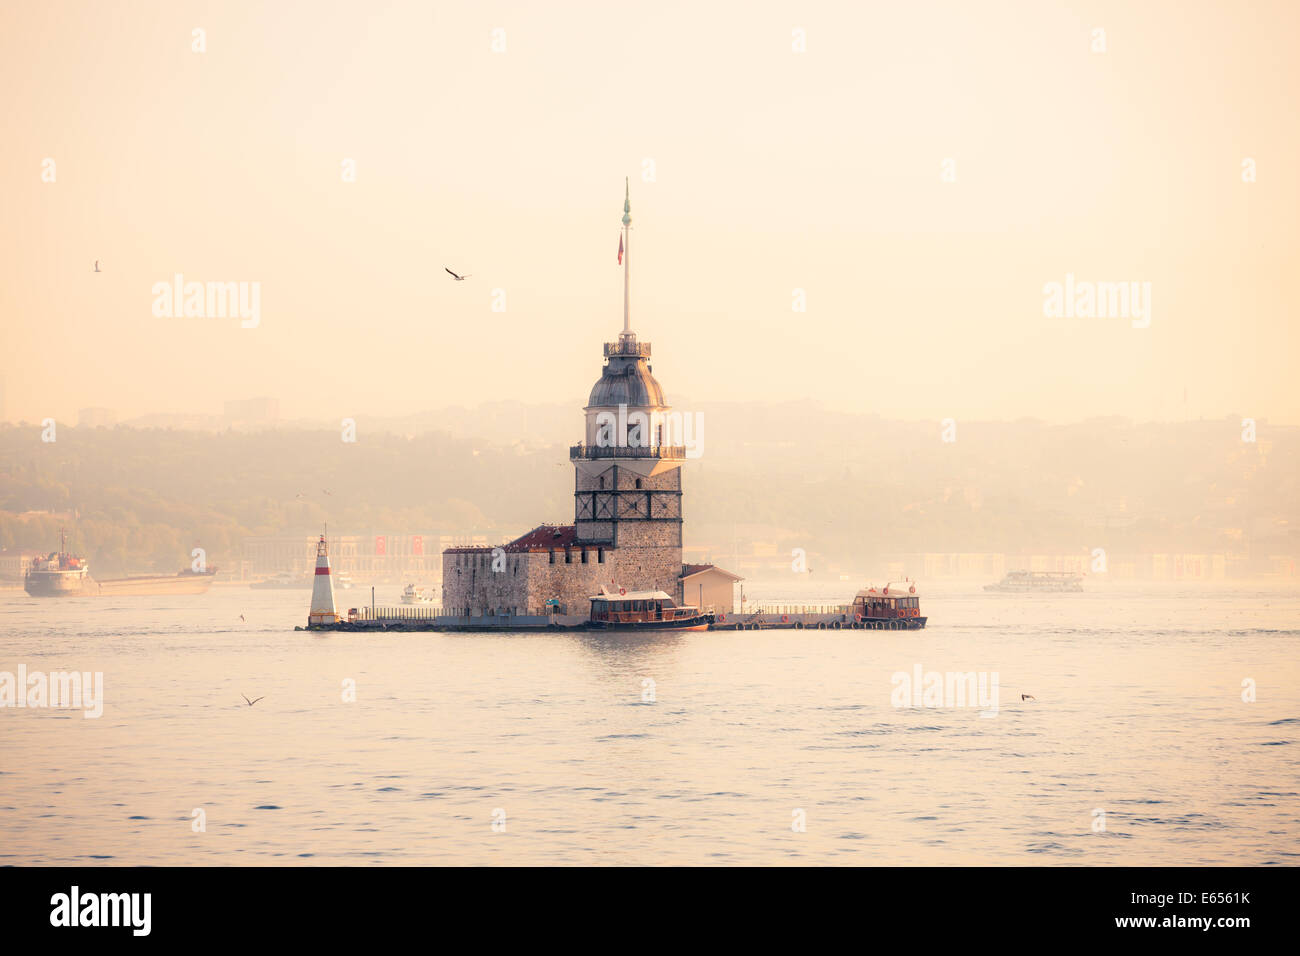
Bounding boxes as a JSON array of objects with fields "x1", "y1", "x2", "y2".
[{"x1": 0, "y1": 403, "x2": 1300, "y2": 572}]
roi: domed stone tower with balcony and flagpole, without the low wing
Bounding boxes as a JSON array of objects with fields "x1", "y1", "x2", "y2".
[{"x1": 569, "y1": 180, "x2": 686, "y2": 594}]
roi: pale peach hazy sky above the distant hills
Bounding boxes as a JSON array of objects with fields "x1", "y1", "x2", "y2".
[{"x1": 0, "y1": 0, "x2": 1300, "y2": 426}]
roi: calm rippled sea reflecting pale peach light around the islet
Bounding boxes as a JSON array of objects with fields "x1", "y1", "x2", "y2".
[{"x1": 0, "y1": 584, "x2": 1300, "y2": 865}]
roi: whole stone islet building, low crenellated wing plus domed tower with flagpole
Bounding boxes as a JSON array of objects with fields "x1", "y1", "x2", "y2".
[{"x1": 442, "y1": 185, "x2": 731, "y2": 617}]
